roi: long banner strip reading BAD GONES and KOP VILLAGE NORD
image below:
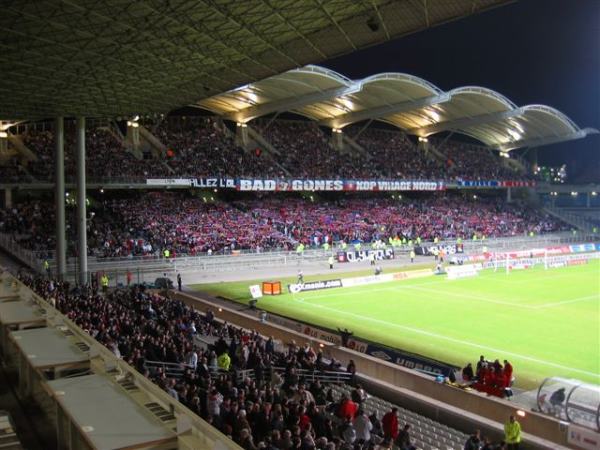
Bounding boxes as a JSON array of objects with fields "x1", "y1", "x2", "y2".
[{"x1": 146, "y1": 177, "x2": 446, "y2": 192}]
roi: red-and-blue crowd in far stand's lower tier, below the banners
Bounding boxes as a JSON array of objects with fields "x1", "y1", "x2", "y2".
[{"x1": 0, "y1": 192, "x2": 564, "y2": 257}]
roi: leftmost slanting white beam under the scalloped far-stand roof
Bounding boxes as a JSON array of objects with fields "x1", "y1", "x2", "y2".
[{"x1": 223, "y1": 83, "x2": 362, "y2": 122}]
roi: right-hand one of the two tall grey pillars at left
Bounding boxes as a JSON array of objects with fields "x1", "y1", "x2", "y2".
[{"x1": 75, "y1": 117, "x2": 87, "y2": 285}]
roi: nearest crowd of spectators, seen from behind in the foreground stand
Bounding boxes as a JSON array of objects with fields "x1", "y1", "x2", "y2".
[{"x1": 20, "y1": 274, "x2": 422, "y2": 450}]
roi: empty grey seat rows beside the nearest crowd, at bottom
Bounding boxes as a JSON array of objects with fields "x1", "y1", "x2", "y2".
[{"x1": 331, "y1": 385, "x2": 469, "y2": 450}]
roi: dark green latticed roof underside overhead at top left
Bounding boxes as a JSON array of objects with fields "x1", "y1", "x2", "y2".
[{"x1": 0, "y1": 0, "x2": 512, "y2": 120}]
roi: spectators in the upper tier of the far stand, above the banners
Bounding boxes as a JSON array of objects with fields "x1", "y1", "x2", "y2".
[{"x1": 1, "y1": 116, "x2": 523, "y2": 185}]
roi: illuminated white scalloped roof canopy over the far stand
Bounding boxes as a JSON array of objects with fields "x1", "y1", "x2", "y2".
[{"x1": 196, "y1": 65, "x2": 598, "y2": 151}]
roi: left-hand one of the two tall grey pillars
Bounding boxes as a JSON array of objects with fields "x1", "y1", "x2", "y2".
[{"x1": 54, "y1": 117, "x2": 67, "y2": 280}]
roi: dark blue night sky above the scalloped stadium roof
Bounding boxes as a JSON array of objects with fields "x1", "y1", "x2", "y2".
[{"x1": 322, "y1": 0, "x2": 600, "y2": 178}]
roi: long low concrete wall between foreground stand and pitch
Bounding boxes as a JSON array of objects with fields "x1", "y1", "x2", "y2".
[{"x1": 172, "y1": 292, "x2": 567, "y2": 449}]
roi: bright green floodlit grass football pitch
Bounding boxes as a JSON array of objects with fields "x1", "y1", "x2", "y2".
[{"x1": 193, "y1": 260, "x2": 600, "y2": 388}]
